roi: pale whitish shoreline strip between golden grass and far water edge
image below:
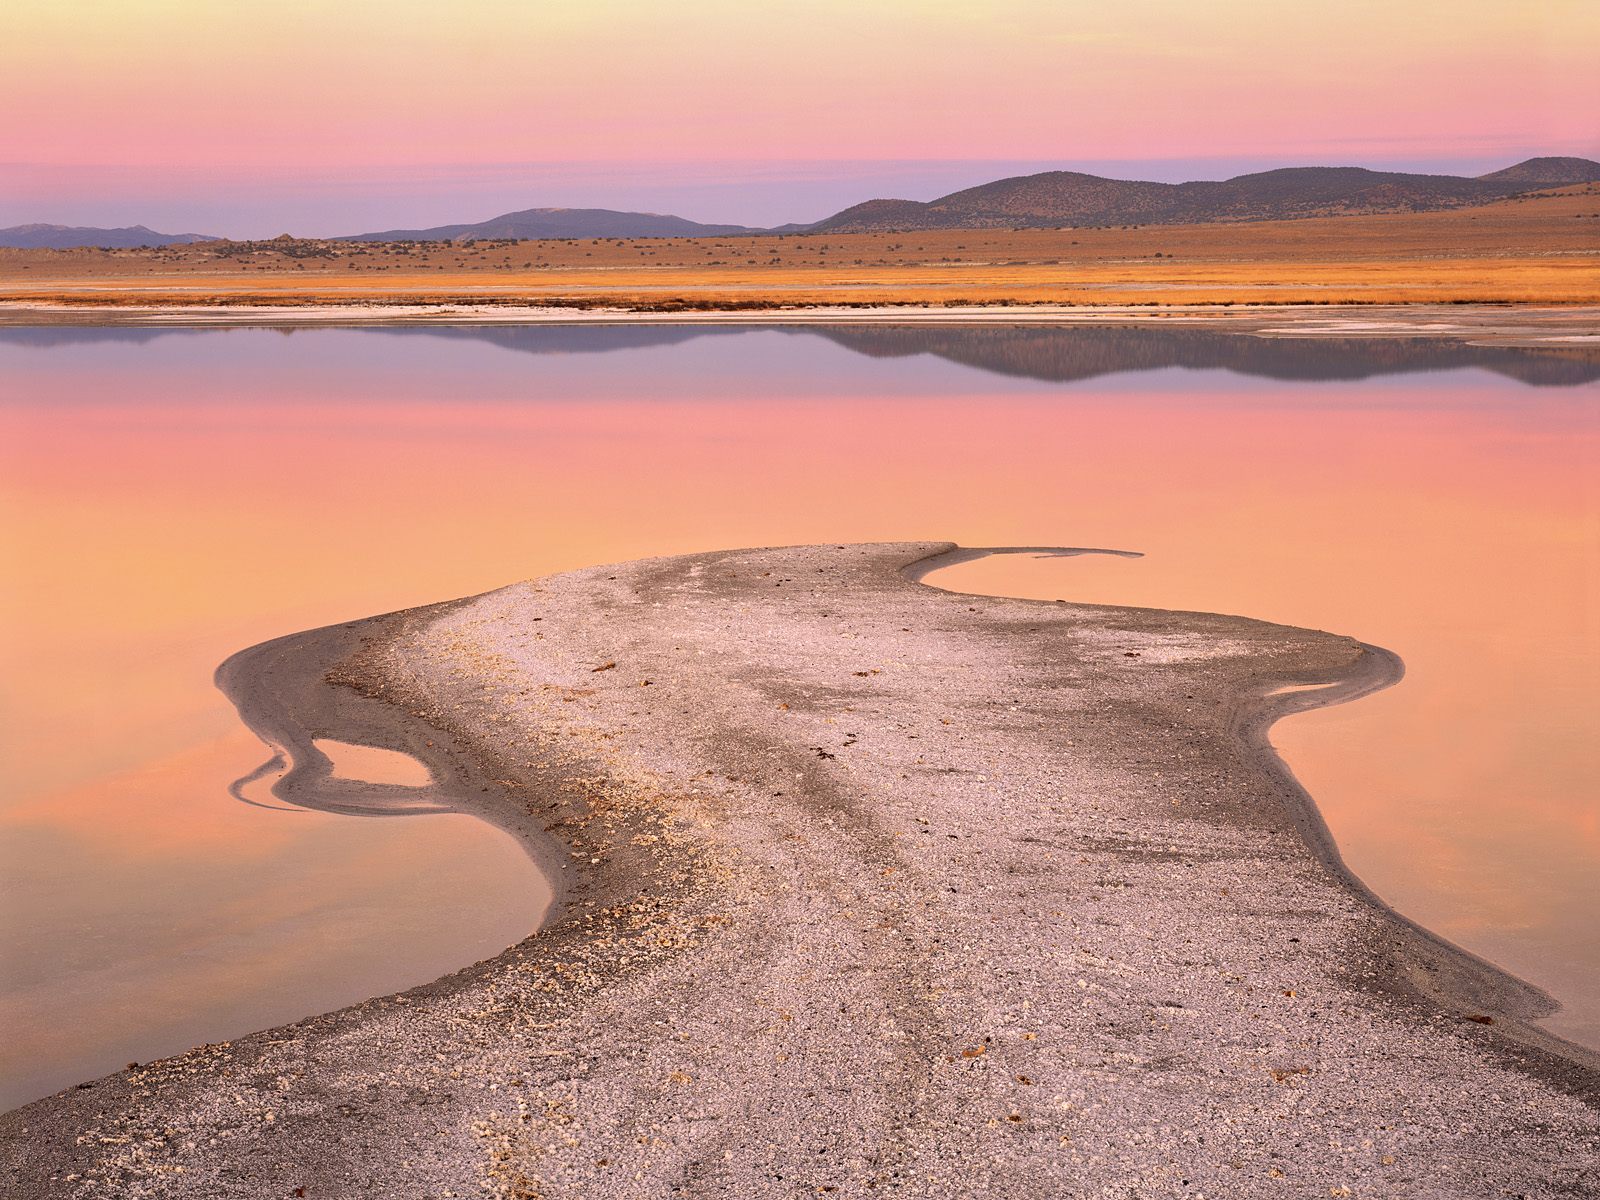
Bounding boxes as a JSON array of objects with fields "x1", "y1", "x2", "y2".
[{"x1": 0, "y1": 299, "x2": 1600, "y2": 352}]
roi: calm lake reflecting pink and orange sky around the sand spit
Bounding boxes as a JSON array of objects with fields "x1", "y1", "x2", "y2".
[{"x1": 0, "y1": 325, "x2": 1600, "y2": 1107}]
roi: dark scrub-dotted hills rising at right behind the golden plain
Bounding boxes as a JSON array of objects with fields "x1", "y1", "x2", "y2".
[{"x1": 811, "y1": 158, "x2": 1600, "y2": 234}]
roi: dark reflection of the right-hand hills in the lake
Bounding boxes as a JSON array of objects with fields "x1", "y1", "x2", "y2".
[{"x1": 818, "y1": 325, "x2": 1600, "y2": 387}]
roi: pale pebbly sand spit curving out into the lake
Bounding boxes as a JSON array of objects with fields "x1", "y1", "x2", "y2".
[{"x1": 0, "y1": 542, "x2": 1600, "y2": 1200}]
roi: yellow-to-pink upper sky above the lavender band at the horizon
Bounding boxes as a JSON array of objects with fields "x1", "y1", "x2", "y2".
[{"x1": 0, "y1": 0, "x2": 1600, "y2": 174}]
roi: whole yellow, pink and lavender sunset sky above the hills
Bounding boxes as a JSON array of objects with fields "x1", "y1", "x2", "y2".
[{"x1": 0, "y1": 0, "x2": 1600, "y2": 237}]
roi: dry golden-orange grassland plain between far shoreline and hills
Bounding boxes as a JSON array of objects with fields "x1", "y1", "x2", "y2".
[{"x1": 0, "y1": 184, "x2": 1600, "y2": 310}]
